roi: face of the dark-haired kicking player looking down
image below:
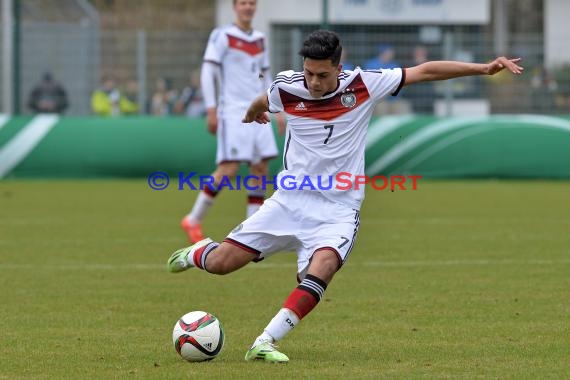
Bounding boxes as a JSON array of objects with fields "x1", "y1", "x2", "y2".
[{"x1": 303, "y1": 58, "x2": 341, "y2": 98}]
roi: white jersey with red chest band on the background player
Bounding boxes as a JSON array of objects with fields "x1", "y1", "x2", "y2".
[{"x1": 204, "y1": 24, "x2": 269, "y2": 116}]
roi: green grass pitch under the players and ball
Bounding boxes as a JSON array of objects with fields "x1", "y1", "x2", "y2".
[{"x1": 0, "y1": 180, "x2": 570, "y2": 379}]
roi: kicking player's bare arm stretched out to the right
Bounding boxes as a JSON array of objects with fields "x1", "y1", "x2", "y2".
[{"x1": 404, "y1": 57, "x2": 524, "y2": 86}]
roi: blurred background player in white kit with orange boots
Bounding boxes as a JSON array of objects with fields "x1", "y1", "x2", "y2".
[{"x1": 181, "y1": 0, "x2": 285, "y2": 243}]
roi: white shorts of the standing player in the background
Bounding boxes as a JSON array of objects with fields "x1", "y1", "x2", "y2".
[{"x1": 216, "y1": 112, "x2": 279, "y2": 164}]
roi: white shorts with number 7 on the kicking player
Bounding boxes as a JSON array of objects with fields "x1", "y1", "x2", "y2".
[{"x1": 225, "y1": 190, "x2": 360, "y2": 279}]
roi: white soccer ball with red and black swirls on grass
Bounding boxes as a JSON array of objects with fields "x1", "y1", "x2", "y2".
[{"x1": 172, "y1": 311, "x2": 224, "y2": 362}]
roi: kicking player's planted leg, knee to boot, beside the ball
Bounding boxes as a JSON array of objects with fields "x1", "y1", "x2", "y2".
[{"x1": 245, "y1": 248, "x2": 340, "y2": 363}]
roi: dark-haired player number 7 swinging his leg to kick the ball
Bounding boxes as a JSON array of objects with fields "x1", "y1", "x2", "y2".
[{"x1": 167, "y1": 30, "x2": 523, "y2": 362}]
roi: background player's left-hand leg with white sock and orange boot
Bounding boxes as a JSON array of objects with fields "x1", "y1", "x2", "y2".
[{"x1": 180, "y1": 162, "x2": 240, "y2": 243}]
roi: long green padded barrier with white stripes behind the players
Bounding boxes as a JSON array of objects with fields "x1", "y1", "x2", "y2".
[{"x1": 0, "y1": 115, "x2": 570, "y2": 178}]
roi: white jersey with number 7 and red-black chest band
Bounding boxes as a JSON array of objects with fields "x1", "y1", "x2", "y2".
[{"x1": 268, "y1": 68, "x2": 405, "y2": 210}]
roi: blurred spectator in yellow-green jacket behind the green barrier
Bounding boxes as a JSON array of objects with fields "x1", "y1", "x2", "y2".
[{"x1": 91, "y1": 76, "x2": 138, "y2": 116}]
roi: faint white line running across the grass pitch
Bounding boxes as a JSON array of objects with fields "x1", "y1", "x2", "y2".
[{"x1": 0, "y1": 259, "x2": 570, "y2": 272}]
